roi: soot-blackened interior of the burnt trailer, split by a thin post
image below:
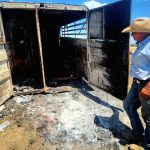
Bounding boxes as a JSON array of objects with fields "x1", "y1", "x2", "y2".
[{"x1": 2, "y1": 9, "x2": 87, "y2": 88}]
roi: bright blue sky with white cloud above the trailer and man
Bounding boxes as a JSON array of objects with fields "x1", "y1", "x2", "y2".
[{"x1": 0, "y1": 0, "x2": 150, "y2": 43}]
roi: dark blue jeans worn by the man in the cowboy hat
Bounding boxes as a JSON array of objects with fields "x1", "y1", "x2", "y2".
[{"x1": 123, "y1": 82, "x2": 150, "y2": 150}]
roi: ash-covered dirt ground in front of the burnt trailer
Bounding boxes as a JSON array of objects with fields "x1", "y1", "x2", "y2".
[{"x1": 0, "y1": 82, "x2": 138, "y2": 150}]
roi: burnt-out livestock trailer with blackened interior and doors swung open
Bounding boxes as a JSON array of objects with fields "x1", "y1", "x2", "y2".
[{"x1": 0, "y1": 0, "x2": 131, "y2": 104}]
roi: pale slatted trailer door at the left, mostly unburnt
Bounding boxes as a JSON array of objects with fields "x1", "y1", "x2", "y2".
[{"x1": 0, "y1": 10, "x2": 13, "y2": 105}]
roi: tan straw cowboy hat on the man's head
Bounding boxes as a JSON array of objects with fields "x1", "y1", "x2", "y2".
[{"x1": 122, "y1": 17, "x2": 150, "y2": 33}]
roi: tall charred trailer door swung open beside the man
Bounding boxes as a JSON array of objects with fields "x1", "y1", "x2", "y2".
[{"x1": 88, "y1": 0, "x2": 131, "y2": 99}]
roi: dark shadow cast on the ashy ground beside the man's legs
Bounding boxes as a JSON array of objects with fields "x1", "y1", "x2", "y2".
[{"x1": 80, "y1": 90, "x2": 134, "y2": 145}]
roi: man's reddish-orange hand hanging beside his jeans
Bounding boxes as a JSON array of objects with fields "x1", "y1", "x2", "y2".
[{"x1": 140, "y1": 81, "x2": 150, "y2": 99}]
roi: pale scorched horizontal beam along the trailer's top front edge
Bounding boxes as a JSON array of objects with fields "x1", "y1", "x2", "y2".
[{"x1": 0, "y1": 2, "x2": 88, "y2": 11}]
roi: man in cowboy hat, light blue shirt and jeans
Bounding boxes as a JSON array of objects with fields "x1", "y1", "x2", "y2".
[{"x1": 122, "y1": 17, "x2": 150, "y2": 150}]
